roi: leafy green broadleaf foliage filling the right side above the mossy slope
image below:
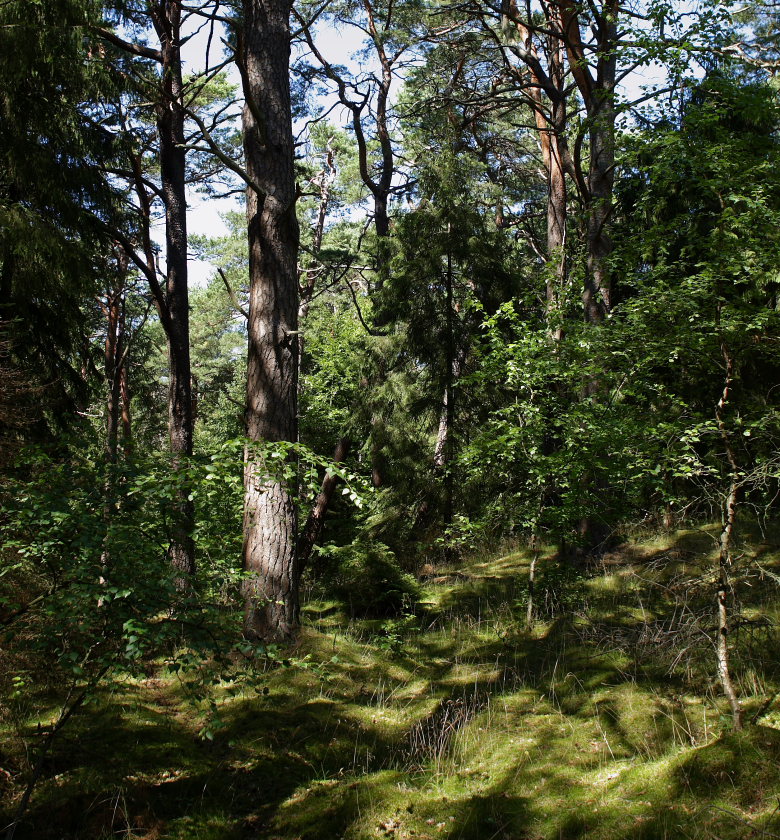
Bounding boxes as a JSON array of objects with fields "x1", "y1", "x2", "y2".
[{"x1": 448, "y1": 76, "x2": 780, "y2": 542}]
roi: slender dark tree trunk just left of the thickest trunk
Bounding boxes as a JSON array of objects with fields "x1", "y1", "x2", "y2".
[{"x1": 152, "y1": 0, "x2": 195, "y2": 588}]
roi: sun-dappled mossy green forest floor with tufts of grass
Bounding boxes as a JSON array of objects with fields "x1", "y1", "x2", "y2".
[{"x1": 0, "y1": 530, "x2": 780, "y2": 840}]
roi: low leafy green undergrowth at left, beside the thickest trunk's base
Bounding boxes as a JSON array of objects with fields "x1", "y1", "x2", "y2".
[{"x1": 2, "y1": 452, "x2": 237, "y2": 676}]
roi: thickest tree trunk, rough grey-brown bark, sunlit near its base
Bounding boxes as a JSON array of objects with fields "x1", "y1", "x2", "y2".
[{"x1": 241, "y1": 0, "x2": 300, "y2": 642}]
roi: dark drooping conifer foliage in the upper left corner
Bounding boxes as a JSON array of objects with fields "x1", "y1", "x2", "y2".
[{"x1": 0, "y1": 0, "x2": 132, "y2": 420}]
